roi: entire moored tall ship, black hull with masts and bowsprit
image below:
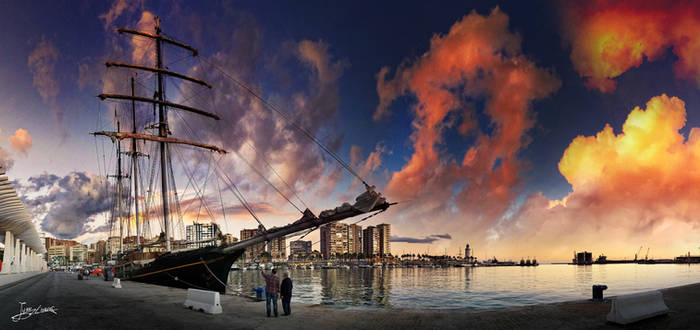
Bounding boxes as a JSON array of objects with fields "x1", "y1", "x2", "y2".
[{"x1": 92, "y1": 18, "x2": 393, "y2": 293}]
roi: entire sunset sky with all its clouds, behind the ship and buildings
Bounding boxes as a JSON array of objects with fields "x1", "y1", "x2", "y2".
[{"x1": 0, "y1": 0, "x2": 700, "y2": 261}]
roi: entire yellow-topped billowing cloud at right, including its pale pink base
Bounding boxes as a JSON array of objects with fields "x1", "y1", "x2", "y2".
[{"x1": 499, "y1": 95, "x2": 700, "y2": 258}]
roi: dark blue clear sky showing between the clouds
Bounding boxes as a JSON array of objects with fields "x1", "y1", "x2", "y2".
[{"x1": 0, "y1": 1, "x2": 700, "y2": 260}]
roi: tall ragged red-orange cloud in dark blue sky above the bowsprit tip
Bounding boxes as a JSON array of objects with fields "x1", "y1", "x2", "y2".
[{"x1": 374, "y1": 8, "x2": 560, "y2": 229}]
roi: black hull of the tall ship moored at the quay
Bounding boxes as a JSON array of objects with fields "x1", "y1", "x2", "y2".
[{"x1": 115, "y1": 247, "x2": 245, "y2": 294}]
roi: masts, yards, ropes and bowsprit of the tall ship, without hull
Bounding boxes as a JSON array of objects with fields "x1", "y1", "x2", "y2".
[{"x1": 93, "y1": 14, "x2": 391, "y2": 269}]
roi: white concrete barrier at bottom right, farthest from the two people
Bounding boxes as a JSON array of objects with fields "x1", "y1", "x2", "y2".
[{"x1": 607, "y1": 291, "x2": 668, "y2": 324}]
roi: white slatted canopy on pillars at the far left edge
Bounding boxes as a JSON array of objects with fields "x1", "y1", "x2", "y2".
[{"x1": 0, "y1": 169, "x2": 46, "y2": 274}]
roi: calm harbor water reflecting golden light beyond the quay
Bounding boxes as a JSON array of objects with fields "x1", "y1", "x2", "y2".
[{"x1": 229, "y1": 264, "x2": 700, "y2": 309}]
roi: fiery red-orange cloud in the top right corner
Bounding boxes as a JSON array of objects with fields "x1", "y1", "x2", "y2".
[{"x1": 565, "y1": 1, "x2": 700, "y2": 93}]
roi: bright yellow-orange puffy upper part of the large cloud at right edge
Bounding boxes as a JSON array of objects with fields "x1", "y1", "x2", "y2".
[{"x1": 559, "y1": 95, "x2": 700, "y2": 224}]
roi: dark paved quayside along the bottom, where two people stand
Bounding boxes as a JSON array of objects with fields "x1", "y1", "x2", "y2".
[{"x1": 0, "y1": 272, "x2": 700, "y2": 330}]
